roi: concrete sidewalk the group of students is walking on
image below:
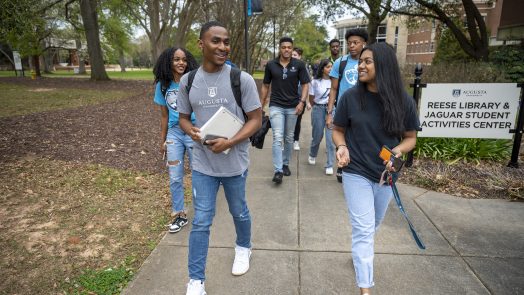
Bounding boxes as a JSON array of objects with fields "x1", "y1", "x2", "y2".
[{"x1": 123, "y1": 114, "x2": 524, "y2": 295}]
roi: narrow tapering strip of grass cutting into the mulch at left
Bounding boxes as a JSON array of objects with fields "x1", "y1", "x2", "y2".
[{"x1": 0, "y1": 83, "x2": 129, "y2": 117}]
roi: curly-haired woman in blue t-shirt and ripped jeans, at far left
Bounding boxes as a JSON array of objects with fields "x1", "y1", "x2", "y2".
[{"x1": 153, "y1": 47, "x2": 198, "y2": 233}]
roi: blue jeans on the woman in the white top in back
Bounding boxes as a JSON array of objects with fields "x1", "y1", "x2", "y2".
[{"x1": 309, "y1": 104, "x2": 335, "y2": 168}]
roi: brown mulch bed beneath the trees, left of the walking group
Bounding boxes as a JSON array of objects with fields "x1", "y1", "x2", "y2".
[{"x1": 0, "y1": 78, "x2": 165, "y2": 173}]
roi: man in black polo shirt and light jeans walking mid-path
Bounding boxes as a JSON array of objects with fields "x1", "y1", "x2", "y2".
[{"x1": 261, "y1": 37, "x2": 310, "y2": 184}]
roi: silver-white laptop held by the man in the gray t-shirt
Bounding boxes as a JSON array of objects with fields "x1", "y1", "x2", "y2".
[{"x1": 200, "y1": 106, "x2": 244, "y2": 154}]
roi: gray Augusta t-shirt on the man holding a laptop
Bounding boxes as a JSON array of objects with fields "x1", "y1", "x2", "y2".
[{"x1": 177, "y1": 65, "x2": 261, "y2": 177}]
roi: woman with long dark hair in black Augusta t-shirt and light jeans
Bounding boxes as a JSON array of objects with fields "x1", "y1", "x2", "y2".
[{"x1": 333, "y1": 43, "x2": 420, "y2": 294}]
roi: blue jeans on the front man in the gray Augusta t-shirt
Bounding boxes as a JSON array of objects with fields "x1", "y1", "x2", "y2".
[{"x1": 188, "y1": 170, "x2": 251, "y2": 281}]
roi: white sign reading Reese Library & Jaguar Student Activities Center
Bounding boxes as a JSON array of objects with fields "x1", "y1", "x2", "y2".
[{"x1": 418, "y1": 83, "x2": 520, "y2": 139}]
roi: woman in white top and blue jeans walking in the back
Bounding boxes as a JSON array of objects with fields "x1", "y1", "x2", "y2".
[{"x1": 308, "y1": 59, "x2": 335, "y2": 175}]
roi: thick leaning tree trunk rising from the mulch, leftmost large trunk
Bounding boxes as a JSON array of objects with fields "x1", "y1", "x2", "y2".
[{"x1": 80, "y1": 0, "x2": 109, "y2": 80}]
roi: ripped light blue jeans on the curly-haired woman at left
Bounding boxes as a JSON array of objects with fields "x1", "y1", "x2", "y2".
[{"x1": 166, "y1": 126, "x2": 193, "y2": 213}]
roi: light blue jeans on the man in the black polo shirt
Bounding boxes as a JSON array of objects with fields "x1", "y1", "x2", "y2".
[{"x1": 269, "y1": 106, "x2": 297, "y2": 172}]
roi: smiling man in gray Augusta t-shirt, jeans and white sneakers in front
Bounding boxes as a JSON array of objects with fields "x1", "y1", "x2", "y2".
[{"x1": 177, "y1": 21, "x2": 262, "y2": 295}]
